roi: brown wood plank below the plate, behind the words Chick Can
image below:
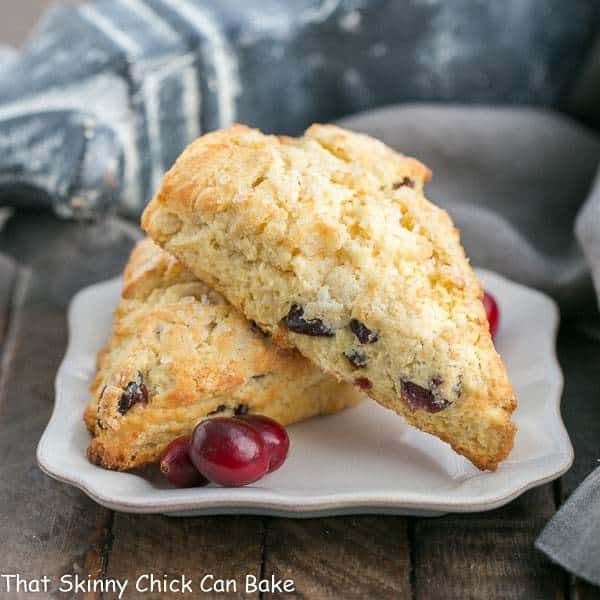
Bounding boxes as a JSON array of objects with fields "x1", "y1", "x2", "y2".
[{"x1": 107, "y1": 514, "x2": 263, "y2": 600}]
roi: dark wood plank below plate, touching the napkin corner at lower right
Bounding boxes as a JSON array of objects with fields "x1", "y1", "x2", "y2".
[{"x1": 414, "y1": 485, "x2": 567, "y2": 600}]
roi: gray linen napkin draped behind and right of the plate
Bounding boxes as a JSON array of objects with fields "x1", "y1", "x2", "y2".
[{"x1": 342, "y1": 105, "x2": 600, "y2": 585}]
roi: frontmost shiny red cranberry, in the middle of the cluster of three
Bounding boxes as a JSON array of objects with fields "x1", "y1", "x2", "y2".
[{"x1": 190, "y1": 417, "x2": 269, "y2": 487}]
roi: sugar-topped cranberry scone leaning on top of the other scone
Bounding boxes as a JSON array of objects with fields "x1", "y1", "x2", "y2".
[{"x1": 142, "y1": 125, "x2": 515, "y2": 469}]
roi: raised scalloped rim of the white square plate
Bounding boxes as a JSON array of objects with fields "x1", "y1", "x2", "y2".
[{"x1": 36, "y1": 269, "x2": 574, "y2": 518}]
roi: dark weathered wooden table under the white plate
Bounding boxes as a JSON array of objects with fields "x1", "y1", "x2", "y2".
[{"x1": 0, "y1": 214, "x2": 600, "y2": 600}]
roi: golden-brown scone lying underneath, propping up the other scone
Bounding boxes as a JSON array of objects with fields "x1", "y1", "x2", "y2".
[{"x1": 85, "y1": 240, "x2": 361, "y2": 470}]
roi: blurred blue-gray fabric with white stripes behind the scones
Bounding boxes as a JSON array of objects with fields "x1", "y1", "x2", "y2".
[{"x1": 0, "y1": 0, "x2": 600, "y2": 216}]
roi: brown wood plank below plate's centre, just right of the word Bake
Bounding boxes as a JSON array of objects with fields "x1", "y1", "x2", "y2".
[{"x1": 264, "y1": 516, "x2": 411, "y2": 600}]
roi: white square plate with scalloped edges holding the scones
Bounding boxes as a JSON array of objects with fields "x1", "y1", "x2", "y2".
[{"x1": 37, "y1": 271, "x2": 573, "y2": 517}]
